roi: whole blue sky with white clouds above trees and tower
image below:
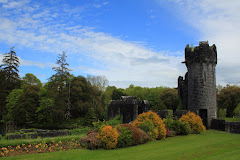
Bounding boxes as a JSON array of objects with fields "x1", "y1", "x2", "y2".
[{"x1": 0, "y1": 0, "x2": 240, "y2": 88}]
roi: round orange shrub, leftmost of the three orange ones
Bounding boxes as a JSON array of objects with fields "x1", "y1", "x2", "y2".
[{"x1": 97, "y1": 125, "x2": 118, "y2": 149}]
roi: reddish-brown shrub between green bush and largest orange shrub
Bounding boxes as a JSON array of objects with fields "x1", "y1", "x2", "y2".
[{"x1": 120, "y1": 124, "x2": 150, "y2": 145}]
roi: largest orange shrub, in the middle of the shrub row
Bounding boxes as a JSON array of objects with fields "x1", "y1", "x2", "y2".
[{"x1": 132, "y1": 111, "x2": 166, "y2": 139}]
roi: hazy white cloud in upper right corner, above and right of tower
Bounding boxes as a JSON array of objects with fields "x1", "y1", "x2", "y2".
[{"x1": 157, "y1": 0, "x2": 240, "y2": 85}]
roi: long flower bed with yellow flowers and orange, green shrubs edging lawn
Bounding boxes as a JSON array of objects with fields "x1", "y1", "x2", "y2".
[{"x1": 0, "y1": 111, "x2": 206, "y2": 157}]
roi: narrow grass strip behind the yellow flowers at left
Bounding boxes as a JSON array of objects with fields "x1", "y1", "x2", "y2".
[{"x1": 0, "y1": 134, "x2": 86, "y2": 147}]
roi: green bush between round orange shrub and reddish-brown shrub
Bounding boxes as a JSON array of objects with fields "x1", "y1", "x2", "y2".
[{"x1": 117, "y1": 126, "x2": 132, "y2": 148}]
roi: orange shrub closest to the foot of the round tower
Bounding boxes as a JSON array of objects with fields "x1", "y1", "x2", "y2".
[{"x1": 180, "y1": 111, "x2": 206, "y2": 133}]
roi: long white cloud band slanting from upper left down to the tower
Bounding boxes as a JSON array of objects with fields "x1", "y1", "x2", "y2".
[{"x1": 0, "y1": 0, "x2": 186, "y2": 87}]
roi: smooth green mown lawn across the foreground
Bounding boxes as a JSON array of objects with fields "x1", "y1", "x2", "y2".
[{"x1": 2, "y1": 130, "x2": 240, "y2": 160}]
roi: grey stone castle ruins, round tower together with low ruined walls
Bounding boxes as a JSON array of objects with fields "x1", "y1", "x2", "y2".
[{"x1": 108, "y1": 41, "x2": 217, "y2": 128}]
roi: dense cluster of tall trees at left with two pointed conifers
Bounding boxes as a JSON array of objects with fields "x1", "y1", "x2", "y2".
[{"x1": 0, "y1": 49, "x2": 106, "y2": 131}]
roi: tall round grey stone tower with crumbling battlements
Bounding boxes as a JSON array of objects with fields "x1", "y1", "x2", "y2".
[{"x1": 178, "y1": 41, "x2": 217, "y2": 128}]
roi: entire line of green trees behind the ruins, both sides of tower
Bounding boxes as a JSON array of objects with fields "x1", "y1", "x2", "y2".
[{"x1": 0, "y1": 48, "x2": 240, "y2": 130}]
